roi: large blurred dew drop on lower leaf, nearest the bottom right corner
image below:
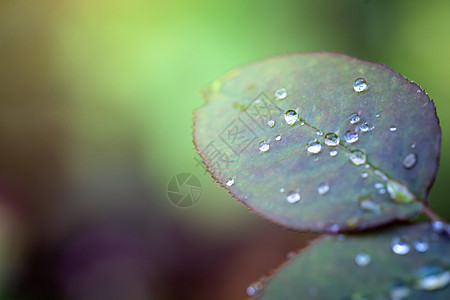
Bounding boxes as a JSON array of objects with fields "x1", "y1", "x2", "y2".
[{"x1": 415, "y1": 264, "x2": 450, "y2": 291}]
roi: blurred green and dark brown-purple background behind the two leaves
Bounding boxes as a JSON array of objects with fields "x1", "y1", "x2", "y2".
[{"x1": 0, "y1": 0, "x2": 450, "y2": 300}]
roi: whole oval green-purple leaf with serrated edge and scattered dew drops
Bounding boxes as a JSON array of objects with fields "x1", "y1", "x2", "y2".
[{"x1": 194, "y1": 52, "x2": 441, "y2": 232}]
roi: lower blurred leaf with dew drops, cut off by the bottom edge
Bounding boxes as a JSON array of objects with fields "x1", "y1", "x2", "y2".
[{"x1": 255, "y1": 224, "x2": 450, "y2": 300}]
